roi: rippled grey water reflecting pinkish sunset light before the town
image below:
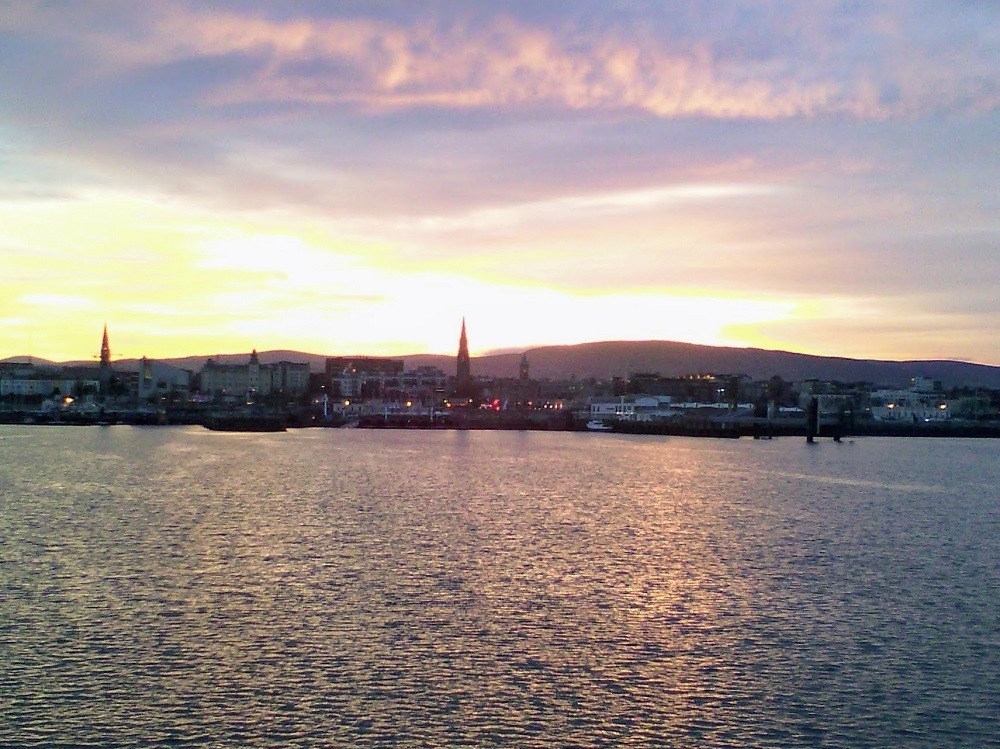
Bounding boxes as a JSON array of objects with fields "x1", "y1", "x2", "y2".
[{"x1": 0, "y1": 427, "x2": 1000, "y2": 747}]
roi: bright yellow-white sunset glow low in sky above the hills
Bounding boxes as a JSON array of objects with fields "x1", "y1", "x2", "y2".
[{"x1": 0, "y1": 190, "x2": 795, "y2": 358}]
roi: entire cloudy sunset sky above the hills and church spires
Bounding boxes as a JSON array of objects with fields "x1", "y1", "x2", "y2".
[{"x1": 0, "y1": 0, "x2": 1000, "y2": 365}]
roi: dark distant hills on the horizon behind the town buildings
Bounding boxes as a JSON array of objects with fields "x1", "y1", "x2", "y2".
[{"x1": 5, "y1": 341, "x2": 1000, "y2": 389}]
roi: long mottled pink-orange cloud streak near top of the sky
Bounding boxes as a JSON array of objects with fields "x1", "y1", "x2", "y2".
[{"x1": 56, "y1": 9, "x2": 984, "y2": 120}]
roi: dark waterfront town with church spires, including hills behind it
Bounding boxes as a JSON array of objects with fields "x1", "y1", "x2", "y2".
[{"x1": 0, "y1": 318, "x2": 1000, "y2": 432}]
